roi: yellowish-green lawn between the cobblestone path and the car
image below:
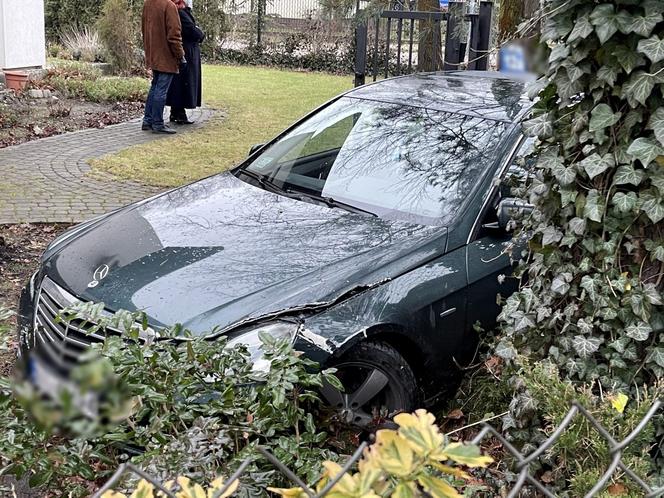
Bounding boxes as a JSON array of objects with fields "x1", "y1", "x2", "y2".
[{"x1": 92, "y1": 65, "x2": 352, "y2": 187}]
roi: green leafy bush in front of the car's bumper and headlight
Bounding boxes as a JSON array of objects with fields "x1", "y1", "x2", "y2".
[{"x1": 0, "y1": 313, "x2": 338, "y2": 496}]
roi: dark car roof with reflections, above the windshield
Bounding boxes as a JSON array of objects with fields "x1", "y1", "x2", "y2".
[{"x1": 346, "y1": 71, "x2": 534, "y2": 123}]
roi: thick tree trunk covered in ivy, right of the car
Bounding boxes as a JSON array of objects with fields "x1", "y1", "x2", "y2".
[{"x1": 498, "y1": 0, "x2": 664, "y2": 394}]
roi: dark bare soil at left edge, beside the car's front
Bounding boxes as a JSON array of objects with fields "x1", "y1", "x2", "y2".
[{"x1": 0, "y1": 224, "x2": 69, "y2": 376}]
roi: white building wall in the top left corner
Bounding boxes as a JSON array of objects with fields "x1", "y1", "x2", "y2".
[{"x1": 0, "y1": 0, "x2": 46, "y2": 69}]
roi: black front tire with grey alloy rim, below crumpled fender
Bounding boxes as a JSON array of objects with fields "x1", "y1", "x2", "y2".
[{"x1": 321, "y1": 341, "x2": 420, "y2": 429}]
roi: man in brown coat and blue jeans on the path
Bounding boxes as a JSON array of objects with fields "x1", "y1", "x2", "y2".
[{"x1": 142, "y1": 0, "x2": 187, "y2": 134}]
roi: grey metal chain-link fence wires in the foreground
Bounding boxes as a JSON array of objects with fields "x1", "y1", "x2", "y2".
[{"x1": 93, "y1": 400, "x2": 664, "y2": 498}]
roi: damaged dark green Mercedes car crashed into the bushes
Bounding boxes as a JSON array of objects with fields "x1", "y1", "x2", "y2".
[{"x1": 20, "y1": 71, "x2": 531, "y2": 426}]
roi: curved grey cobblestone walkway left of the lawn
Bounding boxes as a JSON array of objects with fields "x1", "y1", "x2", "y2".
[{"x1": 0, "y1": 109, "x2": 213, "y2": 224}]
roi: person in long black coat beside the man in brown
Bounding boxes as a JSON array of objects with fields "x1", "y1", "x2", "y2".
[{"x1": 166, "y1": 0, "x2": 205, "y2": 124}]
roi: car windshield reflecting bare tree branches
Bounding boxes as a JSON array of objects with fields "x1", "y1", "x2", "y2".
[{"x1": 244, "y1": 97, "x2": 509, "y2": 225}]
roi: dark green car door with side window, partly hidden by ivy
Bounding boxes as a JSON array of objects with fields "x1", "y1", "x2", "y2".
[{"x1": 466, "y1": 134, "x2": 534, "y2": 330}]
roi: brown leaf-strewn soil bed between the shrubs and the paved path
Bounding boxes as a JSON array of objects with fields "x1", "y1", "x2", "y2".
[{"x1": 0, "y1": 90, "x2": 144, "y2": 149}]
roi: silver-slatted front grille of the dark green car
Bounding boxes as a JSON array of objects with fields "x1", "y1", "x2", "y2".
[{"x1": 33, "y1": 277, "x2": 143, "y2": 374}]
